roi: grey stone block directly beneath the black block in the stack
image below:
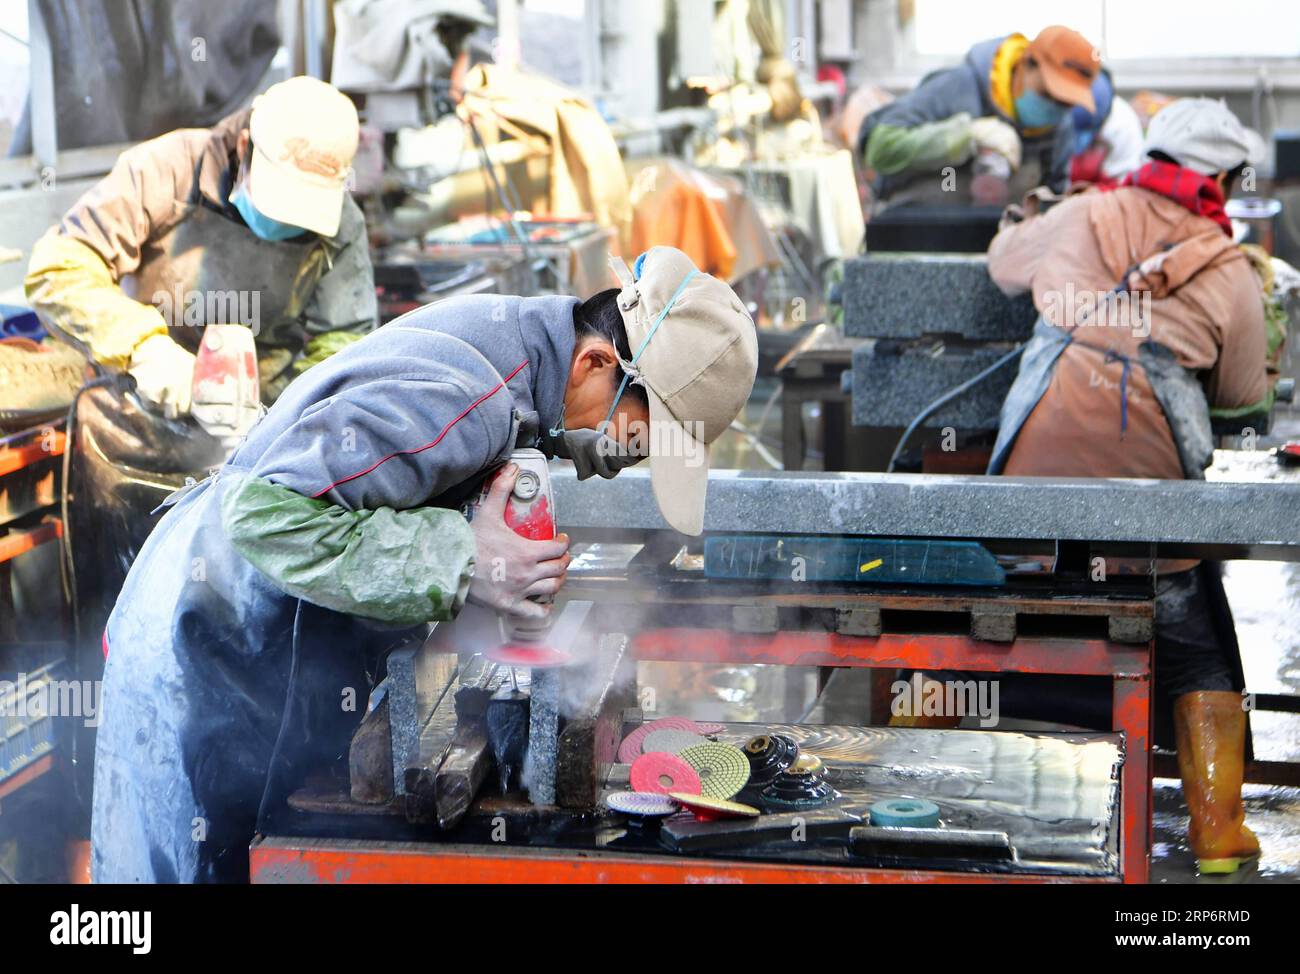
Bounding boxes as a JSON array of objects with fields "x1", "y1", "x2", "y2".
[{"x1": 844, "y1": 254, "x2": 1037, "y2": 342}]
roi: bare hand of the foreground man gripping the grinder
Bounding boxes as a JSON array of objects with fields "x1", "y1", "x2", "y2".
[{"x1": 467, "y1": 463, "x2": 569, "y2": 619}]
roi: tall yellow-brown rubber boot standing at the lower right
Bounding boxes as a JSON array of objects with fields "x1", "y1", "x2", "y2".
[{"x1": 1174, "y1": 691, "x2": 1260, "y2": 874}]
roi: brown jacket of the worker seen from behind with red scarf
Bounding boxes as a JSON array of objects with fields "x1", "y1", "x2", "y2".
[{"x1": 988, "y1": 187, "x2": 1268, "y2": 480}]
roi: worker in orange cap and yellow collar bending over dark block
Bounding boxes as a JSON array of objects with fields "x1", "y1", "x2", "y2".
[{"x1": 858, "y1": 26, "x2": 1100, "y2": 203}]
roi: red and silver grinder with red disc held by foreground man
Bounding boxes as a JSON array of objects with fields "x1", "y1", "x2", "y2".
[{"x1": 465, "y1": 449, "x2": 569, "y2": 668}]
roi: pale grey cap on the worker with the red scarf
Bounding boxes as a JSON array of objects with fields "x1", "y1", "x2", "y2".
[{"x1": 1143, "y1": 98, "x2": 1262, "y2": 176}]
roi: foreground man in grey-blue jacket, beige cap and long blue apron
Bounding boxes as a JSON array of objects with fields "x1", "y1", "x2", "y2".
[{"x1": 92, "y1": 247, "x2": 758, "y2": 882}]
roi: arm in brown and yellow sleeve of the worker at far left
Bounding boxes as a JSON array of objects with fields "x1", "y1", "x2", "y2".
[{"x1": 26, "y1": 133, "x2": 192, "y2": 369}]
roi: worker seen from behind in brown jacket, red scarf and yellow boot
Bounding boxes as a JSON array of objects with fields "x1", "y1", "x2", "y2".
[{"x1": 988, "y1": 99, "x2": 1270, "y2": 873}]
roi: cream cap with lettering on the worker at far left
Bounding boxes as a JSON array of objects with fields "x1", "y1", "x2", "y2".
[{"x1": 248, "y1": 75, "x2": 360, "y2": 237}]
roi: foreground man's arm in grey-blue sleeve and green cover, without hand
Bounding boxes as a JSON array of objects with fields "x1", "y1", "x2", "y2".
[{"x1": 221, "y1": 376, "x2": 511, "y2": 624}]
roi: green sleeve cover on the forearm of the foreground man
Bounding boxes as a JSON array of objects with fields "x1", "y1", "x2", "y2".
[{"x1": 217, "y1": 475, "x2": 475, "y2": 625}]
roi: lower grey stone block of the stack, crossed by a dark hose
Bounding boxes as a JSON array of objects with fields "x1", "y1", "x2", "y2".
[{"x1": 853, "y1": 343, "x2": 1018, "y2": 432}]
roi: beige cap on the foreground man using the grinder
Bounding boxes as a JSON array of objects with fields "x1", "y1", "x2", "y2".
[{"x1": 616, "y1": 247, "x2": 758, "y2": 534}]
